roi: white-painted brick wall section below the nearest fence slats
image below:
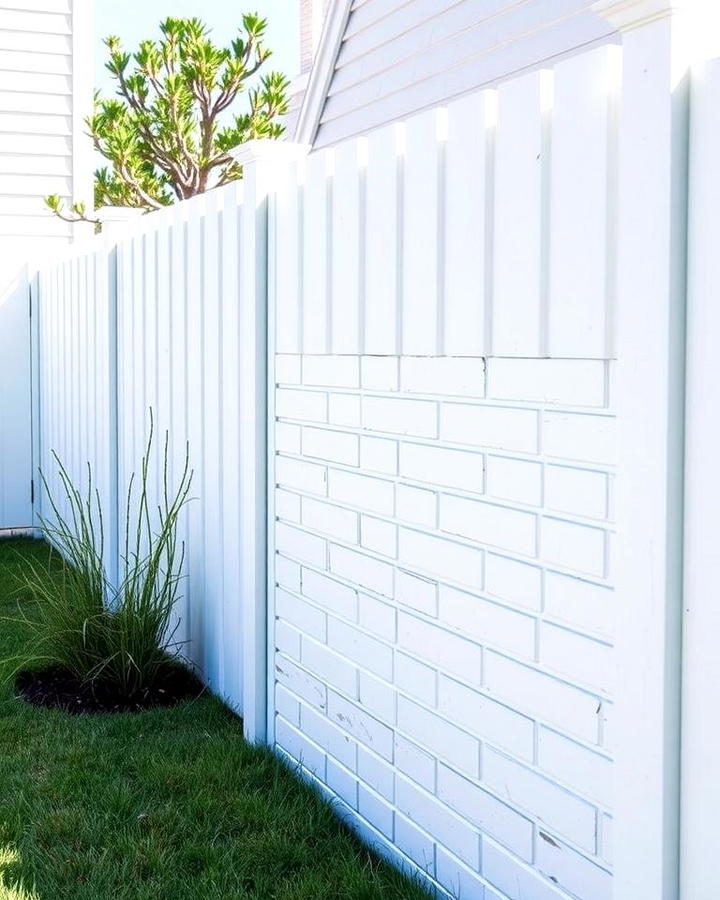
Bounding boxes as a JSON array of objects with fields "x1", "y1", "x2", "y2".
[{"x1": 272, "y1": 354, "x2": 615, "y2": 900}]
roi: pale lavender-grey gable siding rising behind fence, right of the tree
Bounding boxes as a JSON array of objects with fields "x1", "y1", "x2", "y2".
[{"x1": 314, "y1": 0, "x2": 613, "y2": 147}]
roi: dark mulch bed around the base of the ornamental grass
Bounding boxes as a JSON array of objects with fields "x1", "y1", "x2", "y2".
[{"x1": 15, "y1": 663, "x2": 205, "y2": 715}]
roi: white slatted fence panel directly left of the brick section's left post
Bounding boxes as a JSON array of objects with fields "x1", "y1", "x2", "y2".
[{"x1": 118, "y1": 186, "x2": 245, "y2": 709}]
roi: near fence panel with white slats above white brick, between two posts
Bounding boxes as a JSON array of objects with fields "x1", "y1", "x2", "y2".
[{"x1": 269, "y1": 47, "x2": 618, "y2": 900}]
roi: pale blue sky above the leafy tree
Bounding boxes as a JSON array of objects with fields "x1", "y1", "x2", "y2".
[{"x1": 95, "y1": 0, "x2": 300, "y2": 93}]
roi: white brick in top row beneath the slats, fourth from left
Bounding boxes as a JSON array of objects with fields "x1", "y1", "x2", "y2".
[{"x1": 400, "y1": 356, "x2": 485, "y2": 397}]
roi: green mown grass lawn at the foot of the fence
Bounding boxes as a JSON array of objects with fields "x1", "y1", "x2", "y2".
[{"x1": 0, "y1": 540, "x2": 428, "y2": 900}]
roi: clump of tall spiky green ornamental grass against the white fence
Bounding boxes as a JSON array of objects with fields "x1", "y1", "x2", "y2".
[{"x1": 9, "y1": 415, "x2": 192, "y2": 700}]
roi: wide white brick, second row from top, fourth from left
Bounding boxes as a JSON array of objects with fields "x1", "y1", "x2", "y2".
[{"x1": 440, "y1": 403, "x2": 538, "y2": 453}]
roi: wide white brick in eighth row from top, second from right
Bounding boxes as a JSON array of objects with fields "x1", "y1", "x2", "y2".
[{"x1": 438, "y1": 675, "x2": 535, "y2": 761}]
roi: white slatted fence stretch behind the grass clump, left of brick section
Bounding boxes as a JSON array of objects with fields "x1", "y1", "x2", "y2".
[{"x1": 37, "y1": 179, "x2": 264, "y2": 710}]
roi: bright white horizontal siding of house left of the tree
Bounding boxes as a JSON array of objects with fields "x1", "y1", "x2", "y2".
[{"x1": 0, "y1": 0, "x2": 92, "y2": 261}]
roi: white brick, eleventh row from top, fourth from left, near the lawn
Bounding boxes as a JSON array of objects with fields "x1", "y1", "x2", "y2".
[{"x1": 395, "y1": 776, "x2": 480, "y2": 869}]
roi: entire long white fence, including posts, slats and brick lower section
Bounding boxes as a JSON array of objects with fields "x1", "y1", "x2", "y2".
[{"x1": 18, "y1": 19, "x2": 718, "y2": 900}]
